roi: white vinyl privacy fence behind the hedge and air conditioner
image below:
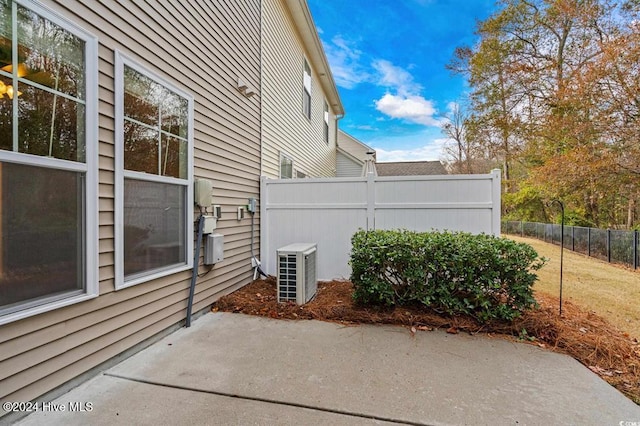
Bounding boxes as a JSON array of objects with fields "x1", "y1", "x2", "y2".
[{"x1": 260, "y1": 170, "x2": 500, "y2": 280}]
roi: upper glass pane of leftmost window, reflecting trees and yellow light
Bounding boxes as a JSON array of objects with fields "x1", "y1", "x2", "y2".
[{"x1": 0, "y1": 0, "x2": 85, "y2": 162}]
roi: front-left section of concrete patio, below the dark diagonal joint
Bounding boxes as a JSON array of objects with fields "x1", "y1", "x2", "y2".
[{"x1": 20, "y1": 375, "x2": 393, "y2": 426}]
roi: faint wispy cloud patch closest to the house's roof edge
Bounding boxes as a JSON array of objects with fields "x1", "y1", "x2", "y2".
[{"x1": 324, "y1": 35, "x2": 371, "y2": 89}]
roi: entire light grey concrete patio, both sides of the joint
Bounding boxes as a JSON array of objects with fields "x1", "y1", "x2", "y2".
[{"x1": 11, "y1": 313, "x2": 640, "y2": 425}]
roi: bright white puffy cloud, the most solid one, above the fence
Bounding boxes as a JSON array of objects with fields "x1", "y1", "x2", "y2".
[{"x1": 375, "y1": 93, "x2": 442, "y2": 126}]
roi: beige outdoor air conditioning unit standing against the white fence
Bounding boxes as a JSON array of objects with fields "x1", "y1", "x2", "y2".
[{"x1": 278, "y1": 243, "x2": 318, "y2": 305}]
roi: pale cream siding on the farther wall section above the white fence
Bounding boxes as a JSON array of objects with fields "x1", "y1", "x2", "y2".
[{"x1": 262, "y1": 0, "x2": 336, "y2": 178}]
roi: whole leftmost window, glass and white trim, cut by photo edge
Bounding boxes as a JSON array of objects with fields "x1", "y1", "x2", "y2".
[{"x1": 0, "y1": 0, "x2": 98, "y2": 324}]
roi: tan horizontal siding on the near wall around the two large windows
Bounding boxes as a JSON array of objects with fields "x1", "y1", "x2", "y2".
[{"x1": 0, "y1": 0, "x2": 261, "y2": 415}]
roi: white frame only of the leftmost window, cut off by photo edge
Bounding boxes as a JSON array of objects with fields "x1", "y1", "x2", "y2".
[{"x1": 0, "y1": 0, "x2": 100, "y2": 325}]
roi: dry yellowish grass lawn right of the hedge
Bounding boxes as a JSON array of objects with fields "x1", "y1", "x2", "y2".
[{"x1": 503, "y1": 234, "x2": 640, "y2": 340}]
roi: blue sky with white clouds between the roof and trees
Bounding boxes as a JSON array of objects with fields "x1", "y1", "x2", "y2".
[{"x1": 308, "y1": 0, "x2": 495, "y2": 161}]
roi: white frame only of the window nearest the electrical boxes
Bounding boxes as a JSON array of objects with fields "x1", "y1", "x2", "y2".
[{"x1": 114, "y1": 50, "x2": 194, "y2": 290}]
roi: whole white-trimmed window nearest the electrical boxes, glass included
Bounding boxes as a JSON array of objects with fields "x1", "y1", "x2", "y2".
[{"x1": 116, "y1": 52, "x2": 193, "y2": 288}]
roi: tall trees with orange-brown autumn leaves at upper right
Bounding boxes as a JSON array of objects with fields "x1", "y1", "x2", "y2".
[{"x1": 450, "y1": 0, "x2": 640, "y2": 226}]
